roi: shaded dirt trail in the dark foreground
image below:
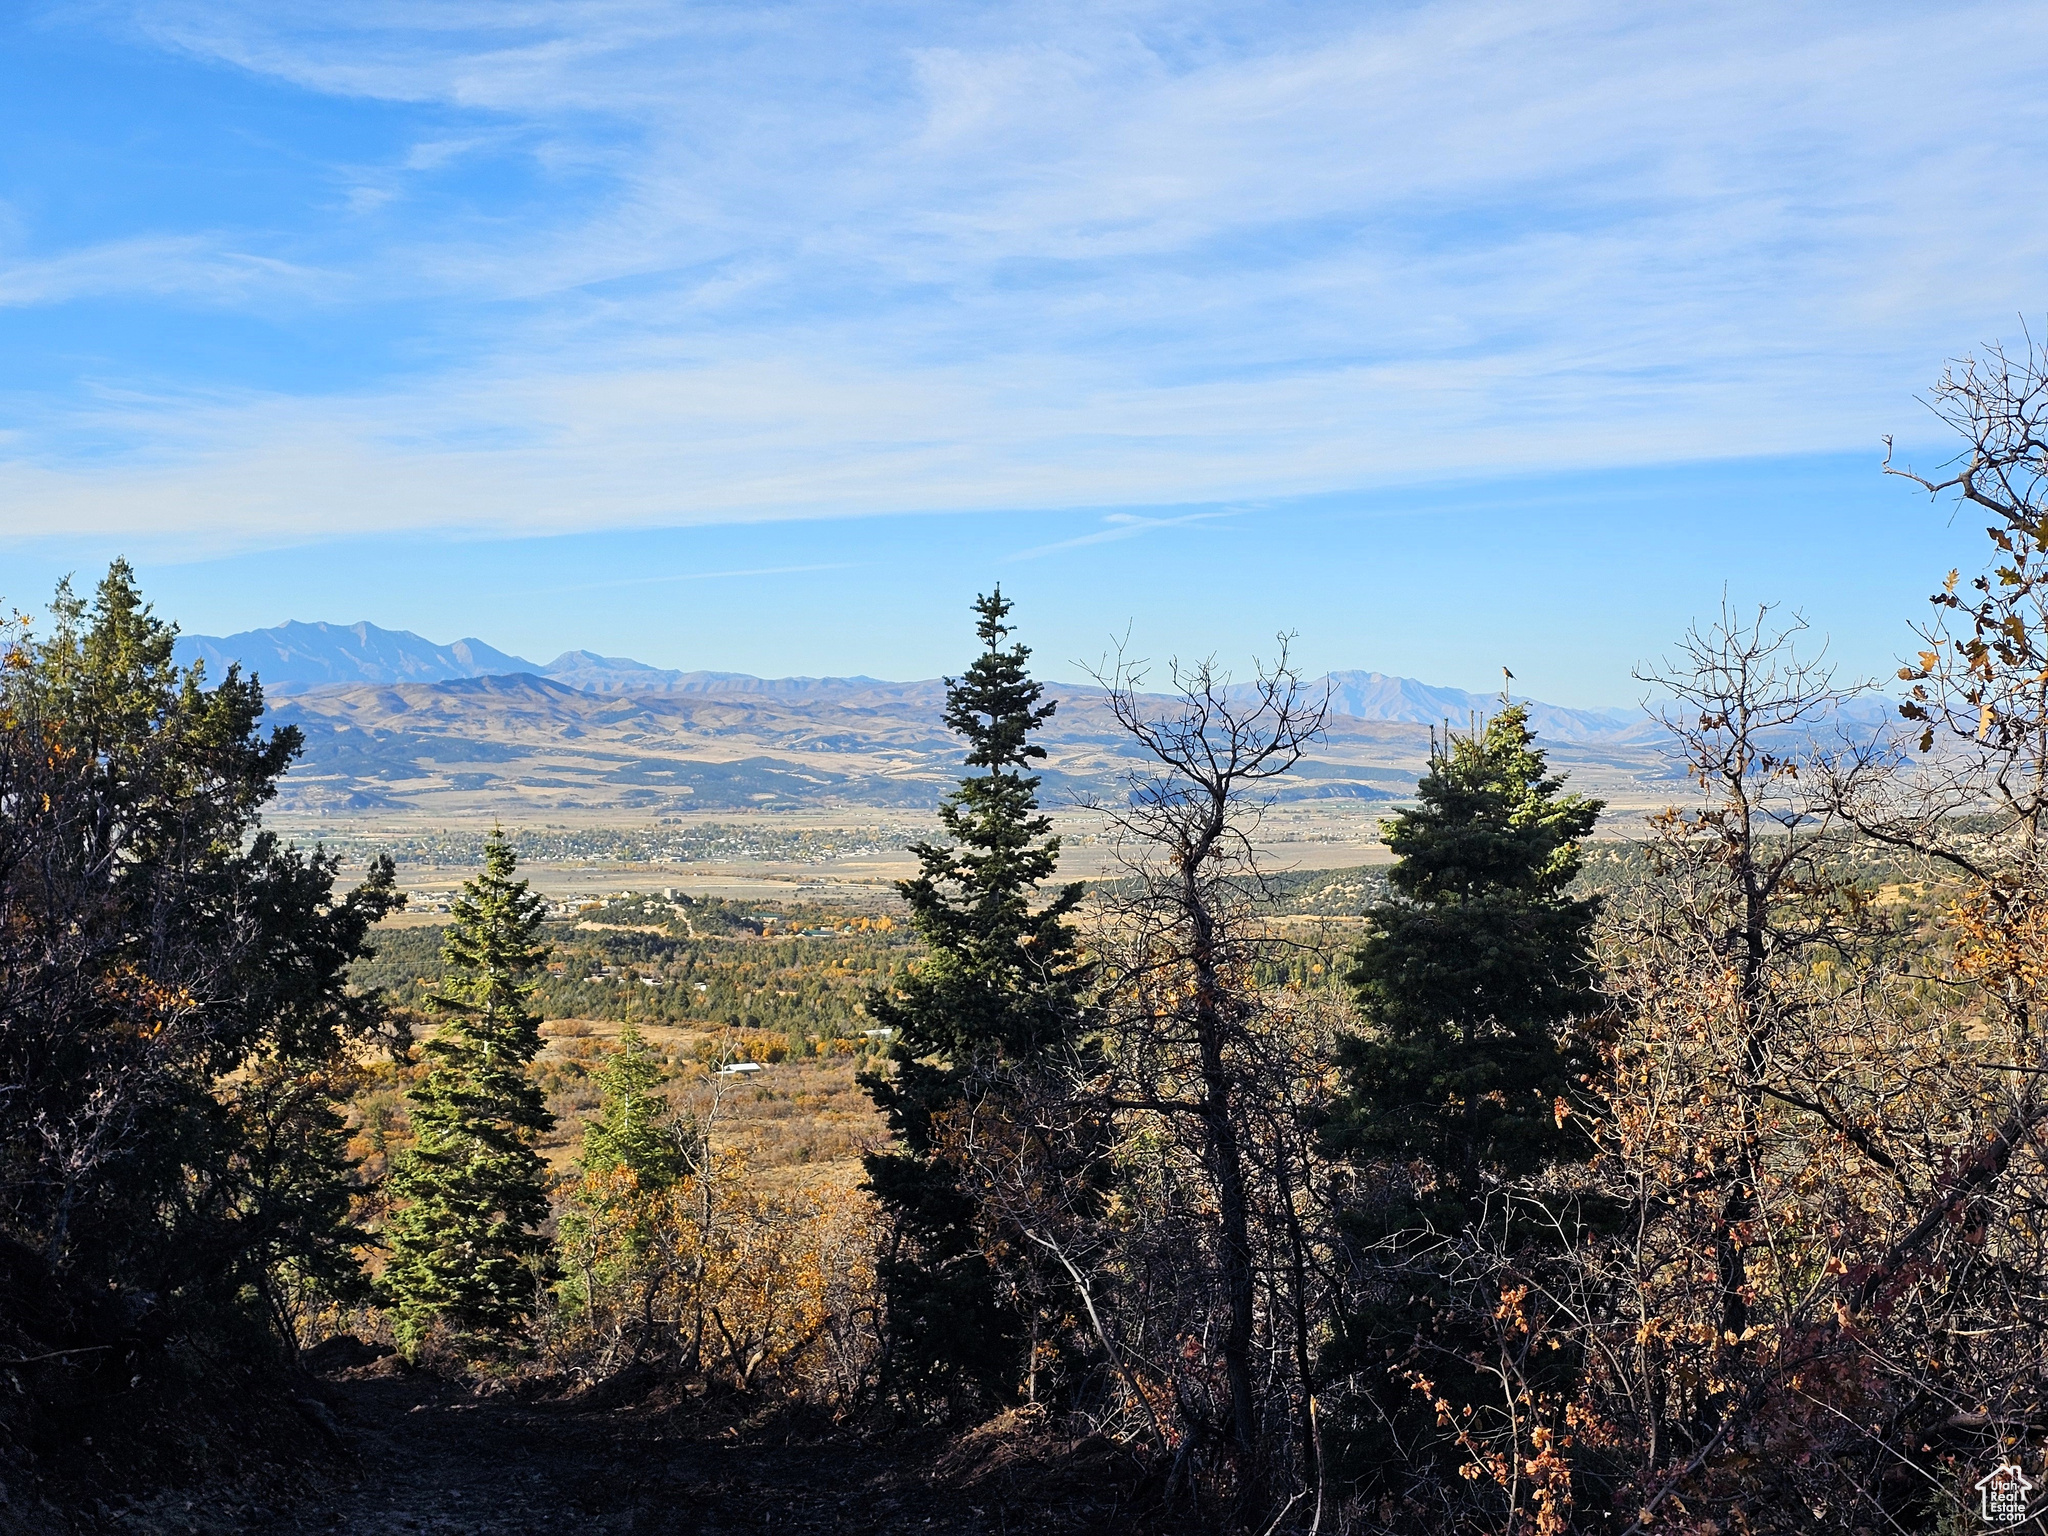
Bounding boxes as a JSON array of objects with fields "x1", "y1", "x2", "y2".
[{"x1": 260, "y1": 1374, "x2": 1130, "y2": 1536}]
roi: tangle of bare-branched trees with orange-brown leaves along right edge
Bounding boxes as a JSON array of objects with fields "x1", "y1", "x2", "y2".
[{"x1": 1511, "y1": 358, "x2": 2048, "y2": 1530}]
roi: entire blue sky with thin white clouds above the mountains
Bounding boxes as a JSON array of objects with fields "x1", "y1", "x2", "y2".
[{"x1": 0, "y1": 0, "x2": 2048, "y2": 702}]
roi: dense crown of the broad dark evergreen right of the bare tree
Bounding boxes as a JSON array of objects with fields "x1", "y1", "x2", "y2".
[{"x1": 1343, "y1": 705, "x2": 1602, "y2": 1217}]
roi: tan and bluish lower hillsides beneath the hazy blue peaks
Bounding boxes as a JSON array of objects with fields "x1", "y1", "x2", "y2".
[{"x1": 260, "y1": 674, "x2": 1661, "y2": 817}]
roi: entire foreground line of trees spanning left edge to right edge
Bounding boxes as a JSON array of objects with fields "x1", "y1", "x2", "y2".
[{"x1": 0, "y1": 339, "x2": 2048, "y2": 1536}]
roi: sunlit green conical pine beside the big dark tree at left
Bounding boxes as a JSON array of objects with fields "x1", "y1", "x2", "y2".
[{"x1": 381, "y1": 831, "x2": 553, "y2": 1354}]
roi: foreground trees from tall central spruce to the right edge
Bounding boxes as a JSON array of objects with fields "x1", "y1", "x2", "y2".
[{"x1": 827, "y1": 354, "x2": 2048, "y2": 1532}]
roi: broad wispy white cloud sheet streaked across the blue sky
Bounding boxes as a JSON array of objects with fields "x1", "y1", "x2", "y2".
[{"x1": 0, "y1": 0, "x2": 2048, "y2": 557}]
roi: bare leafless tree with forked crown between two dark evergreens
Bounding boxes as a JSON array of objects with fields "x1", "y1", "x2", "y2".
[{"x1": 1096, "y1": 637, "x2": 1327, "y2": 1501}]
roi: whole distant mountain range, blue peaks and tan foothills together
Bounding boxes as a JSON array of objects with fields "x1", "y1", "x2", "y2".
[{"x1": 178, "y1": 623, "x2": 1669, "y2": 819}]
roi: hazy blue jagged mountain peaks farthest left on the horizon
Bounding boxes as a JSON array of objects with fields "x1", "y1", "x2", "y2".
[{"x1": 176, "y1": 621, "x2": 539, "y2": 692}]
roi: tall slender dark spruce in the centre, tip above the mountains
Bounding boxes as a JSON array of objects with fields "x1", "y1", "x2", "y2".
[{"x1": 862, "y1": 588, "x2": 1085, "y2": 1403}]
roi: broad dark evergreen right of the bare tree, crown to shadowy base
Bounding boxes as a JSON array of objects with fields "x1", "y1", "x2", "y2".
[{"x1": 1323, "y1": 705, "x2": 1602, "y2": 1493}]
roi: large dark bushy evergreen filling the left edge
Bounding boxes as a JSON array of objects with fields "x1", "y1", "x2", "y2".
[{"x1": 0, "y1": 559, "x2": 403, "y2": 1359}]
